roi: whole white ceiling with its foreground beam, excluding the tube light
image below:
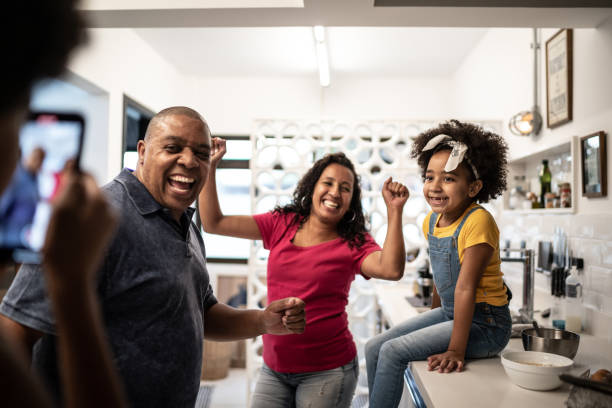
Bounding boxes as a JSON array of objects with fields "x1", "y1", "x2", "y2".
[{"x1": 81, "y1": 0, "x2": 612, "y2": 80}]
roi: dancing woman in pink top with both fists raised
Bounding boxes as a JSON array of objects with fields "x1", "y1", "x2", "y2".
[{"x1": 199, "y1": 138, "x2": 409, "y2": 408}]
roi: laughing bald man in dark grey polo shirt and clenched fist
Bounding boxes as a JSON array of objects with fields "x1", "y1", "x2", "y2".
[{"x1": 0, "y1": 107, "x2": 305, "y2": 408}]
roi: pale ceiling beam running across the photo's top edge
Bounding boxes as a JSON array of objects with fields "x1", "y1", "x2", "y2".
[{"x1": 81, "y1": 0, "x2": 612, "y2": 28}]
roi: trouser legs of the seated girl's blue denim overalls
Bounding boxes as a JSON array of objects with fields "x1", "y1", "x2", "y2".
[{"x1": 365, "y1": 303, "x2": 512, "y2": 408}]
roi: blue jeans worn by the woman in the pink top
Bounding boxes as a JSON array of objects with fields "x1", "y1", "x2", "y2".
[{"x1": 251, "y1": 356, "x2": 359, "y2": 408}]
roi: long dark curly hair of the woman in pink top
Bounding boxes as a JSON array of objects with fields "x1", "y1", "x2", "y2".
[{"x1": 274, "y1": 153, "x2": 366, "y2": 248}]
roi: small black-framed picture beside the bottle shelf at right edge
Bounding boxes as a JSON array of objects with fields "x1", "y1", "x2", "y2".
[{"x1": 580, "y1": 131, "x2": 608, "y2": 198}]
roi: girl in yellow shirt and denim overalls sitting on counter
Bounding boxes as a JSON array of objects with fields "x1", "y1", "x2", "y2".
[{"x1": 366, "y1": 120, "x2": 511, "y2": 408}]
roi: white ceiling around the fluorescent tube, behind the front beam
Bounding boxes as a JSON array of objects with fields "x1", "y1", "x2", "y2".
[{"x1": 135, "y1": 27, "x2": 487, "y2": 77}]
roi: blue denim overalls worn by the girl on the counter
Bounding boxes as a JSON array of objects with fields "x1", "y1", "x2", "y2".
[{"x1": 365, "y1": 207, "x2": 512, "y2": 408}]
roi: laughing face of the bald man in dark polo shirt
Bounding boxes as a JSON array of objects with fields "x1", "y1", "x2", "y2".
[{"x1": 135, "y1": 114, "x2": 210, "y2": 220}]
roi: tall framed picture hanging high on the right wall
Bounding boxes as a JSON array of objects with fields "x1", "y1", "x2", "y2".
[{"x1": 546, "y1": 28, "x2": 573, "y2": 128}]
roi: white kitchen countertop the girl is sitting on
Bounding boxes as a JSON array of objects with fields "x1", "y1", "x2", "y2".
[{"x1": 375, "y1": 283, "x2": 612, "y2": 408}]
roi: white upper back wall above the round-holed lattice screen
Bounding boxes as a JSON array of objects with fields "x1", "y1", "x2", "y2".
[{"x1": 184, "y1": 76, "x2": 451, "y2": 134}]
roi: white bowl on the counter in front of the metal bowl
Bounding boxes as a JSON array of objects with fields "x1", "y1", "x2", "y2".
[{"x1": 501, "y1": 351, "x2": 574, "y2": 391}]
